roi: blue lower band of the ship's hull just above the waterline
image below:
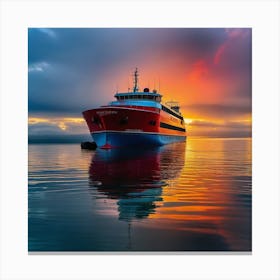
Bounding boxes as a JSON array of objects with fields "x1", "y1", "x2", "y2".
[{"x1": 91, "y1": 131, "x2": 186, "y2": 147}]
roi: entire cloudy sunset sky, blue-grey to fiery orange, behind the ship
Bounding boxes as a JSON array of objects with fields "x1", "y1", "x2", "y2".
[{"x1": 28, "y1": 28, "x2": 252, "y2": 138}]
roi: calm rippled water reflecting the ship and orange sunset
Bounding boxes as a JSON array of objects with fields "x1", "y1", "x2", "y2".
[{"x1": 28, "y1": 138, "x2": 252, "y2": 251}]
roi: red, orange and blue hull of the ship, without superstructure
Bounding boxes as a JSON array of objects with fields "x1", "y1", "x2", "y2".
[{"x1": 83, "y1": 106, "x2": 186, "y2": 148}]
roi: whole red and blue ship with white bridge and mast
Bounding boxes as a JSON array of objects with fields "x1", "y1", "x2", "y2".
[{"x1": 82, "y1": 68, "x2": 187, "y2": 149}]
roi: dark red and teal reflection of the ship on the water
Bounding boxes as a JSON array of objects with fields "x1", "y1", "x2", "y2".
[{"x1": 89, "y1": 145, "x2": 185, "y2": 222}]
